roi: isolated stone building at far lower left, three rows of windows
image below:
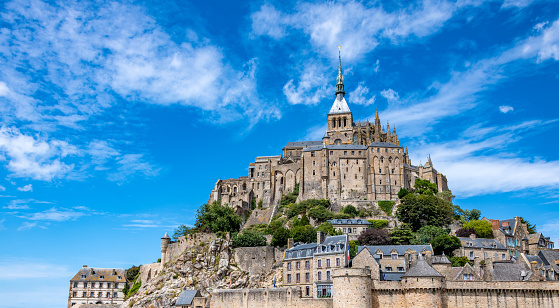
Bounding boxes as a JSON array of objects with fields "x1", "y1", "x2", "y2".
[{"x1": 68, "y1": 265, "x2": 126, "y2": 307}]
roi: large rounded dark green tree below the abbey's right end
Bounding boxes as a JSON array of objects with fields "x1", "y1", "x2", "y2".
[{"x1": 396, "y1": 194, "x2": 453, "y2": 231}]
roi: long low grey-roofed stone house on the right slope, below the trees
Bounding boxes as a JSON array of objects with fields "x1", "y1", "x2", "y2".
[{"x1": 454, "y1": 234, "x2": 510, "y2": 261}]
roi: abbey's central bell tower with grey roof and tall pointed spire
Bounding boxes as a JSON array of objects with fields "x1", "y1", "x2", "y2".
[{"x1": 328, "y1": 47, "x2": 353, "y2": 144}]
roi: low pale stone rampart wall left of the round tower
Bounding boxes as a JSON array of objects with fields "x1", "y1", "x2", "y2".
[{"x1": 210, "y1": 288, "x2": 333, "y2": 308}]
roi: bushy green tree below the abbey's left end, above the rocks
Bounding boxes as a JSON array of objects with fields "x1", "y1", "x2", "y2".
[{"x1": 194, "y1": 201, "x2": 242, "y2": 233}]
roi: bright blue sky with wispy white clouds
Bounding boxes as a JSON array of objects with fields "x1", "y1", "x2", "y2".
[{"x1": 0, "y1": 0, "x2": 559, "y2": 308}]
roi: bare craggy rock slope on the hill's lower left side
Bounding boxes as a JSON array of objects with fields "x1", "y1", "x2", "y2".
[{"x1": 121, "y1": 238, "x2": 282, "y2": 308}]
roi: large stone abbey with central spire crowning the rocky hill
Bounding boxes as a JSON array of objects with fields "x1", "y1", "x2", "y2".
[{"x1": 209, "y1": 50, "x2": 448, "y2": 214}]
